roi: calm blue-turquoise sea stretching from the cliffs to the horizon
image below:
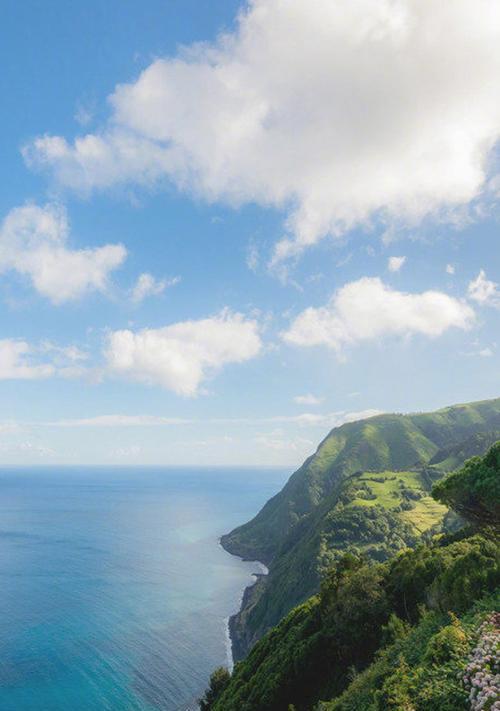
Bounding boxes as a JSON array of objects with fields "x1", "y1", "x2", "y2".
[{"x1": 0, "y1": 468, "x2": 287, "y2": 711}]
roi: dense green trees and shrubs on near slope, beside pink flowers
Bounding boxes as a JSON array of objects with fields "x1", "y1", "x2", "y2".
[{"x1": 209, "y1": 535, "x2": 500, "y2": 711}]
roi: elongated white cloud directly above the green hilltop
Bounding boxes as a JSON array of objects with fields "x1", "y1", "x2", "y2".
[{"x1": 282, "y1": 277, "x2": 474, "y2": 353}]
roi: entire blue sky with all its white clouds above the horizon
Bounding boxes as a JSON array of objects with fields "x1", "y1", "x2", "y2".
[{"x1": 0, "y1": 0, "x2": 500, "y2": 467}]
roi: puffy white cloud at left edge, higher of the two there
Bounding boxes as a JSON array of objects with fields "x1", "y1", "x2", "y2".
[{"x1": 0, "y1": 204, "x2": 127, "y2": 304}]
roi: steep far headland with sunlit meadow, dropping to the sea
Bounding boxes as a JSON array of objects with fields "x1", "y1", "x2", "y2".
[{"x1": 222, "y1": 399, "x2": 500, "y2": 659}]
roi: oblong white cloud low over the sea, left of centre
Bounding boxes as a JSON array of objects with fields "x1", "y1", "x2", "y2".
[{"x1": 106, "y1": 310, "x2": 262, "y2": 395}]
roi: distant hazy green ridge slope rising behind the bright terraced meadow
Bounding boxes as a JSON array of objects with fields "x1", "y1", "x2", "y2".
[{"x1": 222, "y1": 398, "x2": 500, "y2": 563}]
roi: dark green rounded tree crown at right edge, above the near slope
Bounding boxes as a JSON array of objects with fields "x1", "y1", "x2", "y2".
[{"x1": 432, "y1": 442, "x2": 500, "y2": 531}]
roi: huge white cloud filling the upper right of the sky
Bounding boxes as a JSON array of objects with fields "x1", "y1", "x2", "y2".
[{"x1": 24, "y1": 0, "x2": 500, "y2": 259}]
